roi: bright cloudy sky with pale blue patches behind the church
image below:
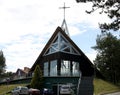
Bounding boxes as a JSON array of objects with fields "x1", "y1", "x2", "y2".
[{"x1": 0, "y1": 0, "x2": 110, "y2": 72}]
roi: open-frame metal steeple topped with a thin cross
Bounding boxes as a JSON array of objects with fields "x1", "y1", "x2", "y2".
[{"x1": 60, "y1": 3, "x2": 70, "y2": 36}]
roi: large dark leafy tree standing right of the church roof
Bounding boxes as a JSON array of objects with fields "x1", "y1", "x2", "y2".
[{"x1": 93, "y1": 32, "x2": 120, "y2": 83}]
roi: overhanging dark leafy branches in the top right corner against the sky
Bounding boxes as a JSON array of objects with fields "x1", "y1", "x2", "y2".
[{"x1": 76, "y1": 0, "x2": 120, "y2": 32}]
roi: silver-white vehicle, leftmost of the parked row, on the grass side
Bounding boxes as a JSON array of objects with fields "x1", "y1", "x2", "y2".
[{"x1": 11, "y1": 86, "x2": 28, "y2": 95}]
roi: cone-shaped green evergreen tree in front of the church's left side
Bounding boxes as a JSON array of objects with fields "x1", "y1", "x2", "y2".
[{"x1": 30, "y1": 65, "x2": 43, "y2": 89}]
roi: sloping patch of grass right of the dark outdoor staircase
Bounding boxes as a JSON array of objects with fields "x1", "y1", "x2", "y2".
[{"x1": 94, "y1": 78, "x2": 120, "y2": 95}]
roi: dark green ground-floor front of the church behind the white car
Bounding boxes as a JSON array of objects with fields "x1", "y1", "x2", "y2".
[{"x1": 44, "y1": 77, "x2": 79, "y2": 95}]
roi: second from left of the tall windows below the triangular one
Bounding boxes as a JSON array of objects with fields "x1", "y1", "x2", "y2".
[{"x1": 50, "y1": 60, "x2": 57, "y2": 76}]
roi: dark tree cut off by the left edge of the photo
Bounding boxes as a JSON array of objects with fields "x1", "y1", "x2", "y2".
[{"x1": 0, "y1": 51, "x2": 6, "y2": 75}]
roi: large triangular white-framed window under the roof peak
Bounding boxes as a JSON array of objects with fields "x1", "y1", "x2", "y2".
[{"x1": 44, "y1": 33, "x2": 80, "y2": 55}]
